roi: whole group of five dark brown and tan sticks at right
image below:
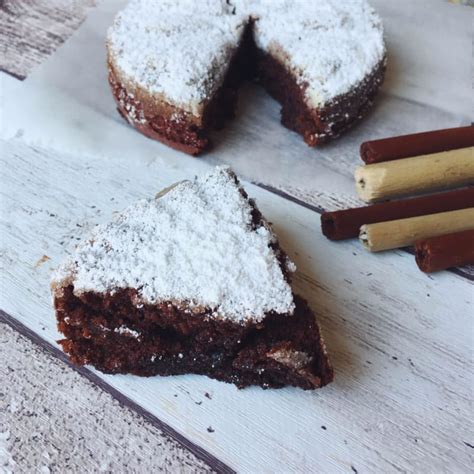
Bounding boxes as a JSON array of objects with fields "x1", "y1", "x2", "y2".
[{"x1": 321, "y1": 126, "x2": 474, "y2": 272}]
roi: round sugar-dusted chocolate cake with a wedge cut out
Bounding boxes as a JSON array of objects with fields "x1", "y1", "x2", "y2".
[{"x1": 107, "y1": 0, "x2": 386, "y2": 155}]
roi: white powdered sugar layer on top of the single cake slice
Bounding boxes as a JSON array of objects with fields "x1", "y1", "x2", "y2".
[{"x1": 53, "y1": 168, "x2": 294, "y2": 322}]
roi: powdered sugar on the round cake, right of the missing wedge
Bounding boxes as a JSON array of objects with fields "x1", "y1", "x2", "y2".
[{"x1": 248, "y1": 0, "x2": 385, "y2": 107}]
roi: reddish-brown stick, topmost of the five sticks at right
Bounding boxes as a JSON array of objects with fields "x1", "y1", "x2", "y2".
[{"x1": 360, "y1": 125, "x2": 474, "y2": 164}]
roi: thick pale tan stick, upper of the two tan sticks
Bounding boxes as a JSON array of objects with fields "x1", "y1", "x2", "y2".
[{"x1": 355, "y1": 147, "x2": 474, "y2": 202}]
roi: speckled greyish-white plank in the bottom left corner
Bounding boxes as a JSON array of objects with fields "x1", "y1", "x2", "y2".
[{"x1": 0, "y1": 321, "x2": 215, "y2": 473}]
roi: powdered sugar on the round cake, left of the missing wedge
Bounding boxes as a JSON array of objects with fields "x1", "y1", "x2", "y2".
[{"x1": 108, "y1": 0, "x2": 245, "y2": 116}]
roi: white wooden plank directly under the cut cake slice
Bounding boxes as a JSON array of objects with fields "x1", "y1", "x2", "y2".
[{"x1": 0, "y1": 142, "x2": 474, "y2": 472}]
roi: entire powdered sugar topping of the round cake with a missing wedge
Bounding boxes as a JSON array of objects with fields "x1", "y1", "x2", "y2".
[{"x1": 108, "y1": 0, "x2": 385, "y2": 115}]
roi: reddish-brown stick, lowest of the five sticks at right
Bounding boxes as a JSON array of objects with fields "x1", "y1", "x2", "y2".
[{"x1": 415, "y1": 230, "x2": 474, "y2": 273}]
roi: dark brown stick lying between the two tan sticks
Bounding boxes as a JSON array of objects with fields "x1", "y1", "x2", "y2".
[{"x1": 321, "y1": 188, "x2": 474, "y2": 240}]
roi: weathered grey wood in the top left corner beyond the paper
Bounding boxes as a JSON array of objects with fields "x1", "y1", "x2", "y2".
[{"x1": 0, "y1": 0, "x2": 96, "y2": 79}]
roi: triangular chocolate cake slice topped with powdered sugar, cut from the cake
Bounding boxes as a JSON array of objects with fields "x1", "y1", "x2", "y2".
[{"x1": 52, "y1": 168, "x2": 333, "y2": 389}]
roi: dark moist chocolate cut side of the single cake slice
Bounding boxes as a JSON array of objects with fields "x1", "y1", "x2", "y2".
[{"x1": 55, "y1": 286, "x2": 333, "y2": 390}]
